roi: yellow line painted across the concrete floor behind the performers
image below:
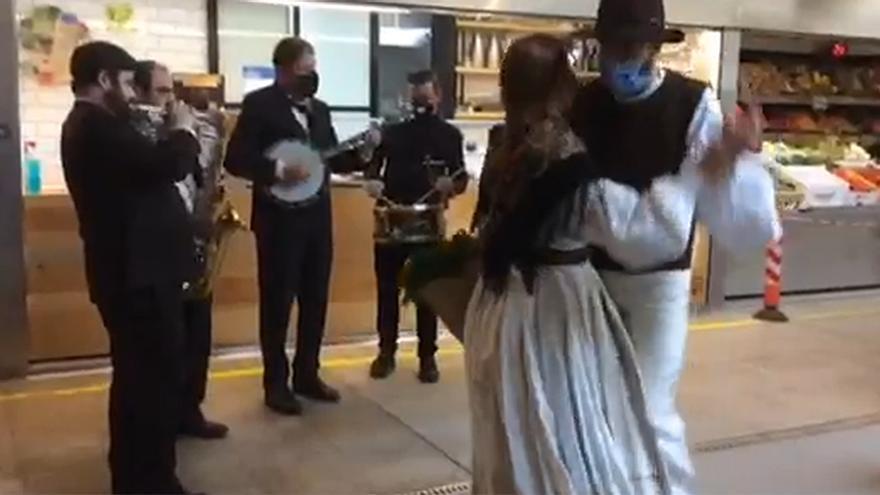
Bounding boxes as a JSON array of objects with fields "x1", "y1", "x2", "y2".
[{"x1": 0, "y1": 310, "x2": 880, "y2": 403}]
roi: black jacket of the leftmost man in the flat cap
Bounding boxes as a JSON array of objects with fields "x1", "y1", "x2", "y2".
[{"x1": 61, "y1": 101, "x2": 199, "y2": 303}]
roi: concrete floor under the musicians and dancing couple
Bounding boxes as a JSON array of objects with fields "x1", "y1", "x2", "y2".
[{"x1": 0, "y1": 293, "x2": 880, "y2": 495}]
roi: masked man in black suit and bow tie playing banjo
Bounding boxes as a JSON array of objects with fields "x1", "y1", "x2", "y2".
[{"x1": 224, "y1": 38, "x2": 370, "y2": 415}]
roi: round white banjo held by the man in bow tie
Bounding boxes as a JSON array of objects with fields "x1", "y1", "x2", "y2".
[{"x1": 265, "y1": 124, "x2": 379, "y2": 209}]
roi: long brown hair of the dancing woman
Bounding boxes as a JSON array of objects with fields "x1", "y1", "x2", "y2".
[{"x1": 488, "y1": 34, "x2": 577, "y2": 213}]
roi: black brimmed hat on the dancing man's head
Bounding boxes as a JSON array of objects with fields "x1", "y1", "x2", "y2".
[{"x1": 573, "y1": 0, "x2": 684, "y2": 43}]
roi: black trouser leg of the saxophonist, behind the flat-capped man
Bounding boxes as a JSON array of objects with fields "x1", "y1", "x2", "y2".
[{"x1": 180, "y1": 296, "x2": 213, "y2": 425}]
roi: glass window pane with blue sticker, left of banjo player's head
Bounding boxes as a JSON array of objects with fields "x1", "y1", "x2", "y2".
[{"x1": 217, "y1": 0, "x2": 293, "y2": 103}]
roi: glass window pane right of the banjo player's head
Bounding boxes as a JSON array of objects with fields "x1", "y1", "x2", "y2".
[{"x1": 299, "y1": 5, "x2": 370, "y2": 108}]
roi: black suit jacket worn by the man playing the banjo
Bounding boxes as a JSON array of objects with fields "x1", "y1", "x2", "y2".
[{"x1": 224, "y1": 85, "x2": 360, "y2": 227}]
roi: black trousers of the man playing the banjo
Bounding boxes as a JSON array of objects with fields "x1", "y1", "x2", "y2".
[{"x1": 254, "y1": 200, "x2": 333, "y2": 391}]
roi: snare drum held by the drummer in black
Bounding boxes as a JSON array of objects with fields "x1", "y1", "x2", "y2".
[{"x1": 373, "y1": 204, "x2": 446, "y2": 244}]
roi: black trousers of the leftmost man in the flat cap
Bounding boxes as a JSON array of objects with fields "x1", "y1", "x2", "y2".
[{"x1": 98, "y1": 287, "x2": 183, "y2": 494}]
